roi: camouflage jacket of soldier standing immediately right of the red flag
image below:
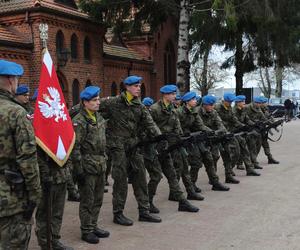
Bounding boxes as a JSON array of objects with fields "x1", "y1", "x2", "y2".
[{"x1": 72, "y1": 107, "x2": 106, "y2": 175}]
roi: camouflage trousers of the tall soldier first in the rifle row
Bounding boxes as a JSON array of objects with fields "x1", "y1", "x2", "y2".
[{"x1": 109, "y1": 148, "x2": 150, "y2": 213}]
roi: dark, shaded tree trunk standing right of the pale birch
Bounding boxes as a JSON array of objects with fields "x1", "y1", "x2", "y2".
[{"x1": 234, "y1": 32, "x2": 244, "y2": 95}]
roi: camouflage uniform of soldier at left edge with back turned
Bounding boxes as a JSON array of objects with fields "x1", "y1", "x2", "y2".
[{"x1": 0, "y1": 89, "x2": 41, "y2": 250}]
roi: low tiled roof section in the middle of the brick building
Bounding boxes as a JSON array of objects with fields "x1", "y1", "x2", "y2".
[{"x1": 103, "y1": 43, "x2": 151, "y2": 62}]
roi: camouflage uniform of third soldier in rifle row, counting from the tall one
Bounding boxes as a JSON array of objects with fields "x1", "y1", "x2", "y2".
[{"x1": 177, "y1": 105, "x2": 219, "y2": 185}]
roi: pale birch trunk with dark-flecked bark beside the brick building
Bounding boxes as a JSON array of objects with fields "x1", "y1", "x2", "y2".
[{"x1": 177, "y1": 0, "x2": 190, "y2": 94}]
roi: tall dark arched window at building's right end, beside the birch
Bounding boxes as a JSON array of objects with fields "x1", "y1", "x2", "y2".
[{"x1": 164, "y1": 41, "x2": 176, "y2": 84}]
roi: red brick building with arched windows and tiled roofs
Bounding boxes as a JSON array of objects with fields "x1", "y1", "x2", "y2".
[{"x1": 0, "y1": 0, "x2": 177, "y2": 106}]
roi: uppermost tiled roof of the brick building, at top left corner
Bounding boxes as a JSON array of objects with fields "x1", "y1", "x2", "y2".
[{"x1": 0, "y1": 0, "x2": 88, "y2": 18}]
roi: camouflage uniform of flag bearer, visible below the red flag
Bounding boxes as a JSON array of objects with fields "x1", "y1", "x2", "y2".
[{"x1": 35, "y1": 147, "x2": 70, "y2": 249}]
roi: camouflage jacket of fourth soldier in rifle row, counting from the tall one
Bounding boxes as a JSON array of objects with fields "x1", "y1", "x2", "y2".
[{"x1": 198, "y1": 107, "x2": 227, "y2": 132}]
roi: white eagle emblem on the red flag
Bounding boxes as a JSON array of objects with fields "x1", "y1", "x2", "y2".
[{"x1": 39, "y1": 87, "x2": 67, "y2": 122}]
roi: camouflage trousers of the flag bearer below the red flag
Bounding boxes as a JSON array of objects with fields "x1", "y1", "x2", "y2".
[{"x1": 35, "y1": 183, "x2": 67, "y2": 248}]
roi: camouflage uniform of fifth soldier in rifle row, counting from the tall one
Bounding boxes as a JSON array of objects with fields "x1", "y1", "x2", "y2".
[{"x1": 216, "y1": 103, "x2": 254, "y2": 172}]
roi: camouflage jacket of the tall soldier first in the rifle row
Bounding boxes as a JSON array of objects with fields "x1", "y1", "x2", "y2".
[{"x1": 99, "y1": 93, "x2": 161, "y2": 149}]
